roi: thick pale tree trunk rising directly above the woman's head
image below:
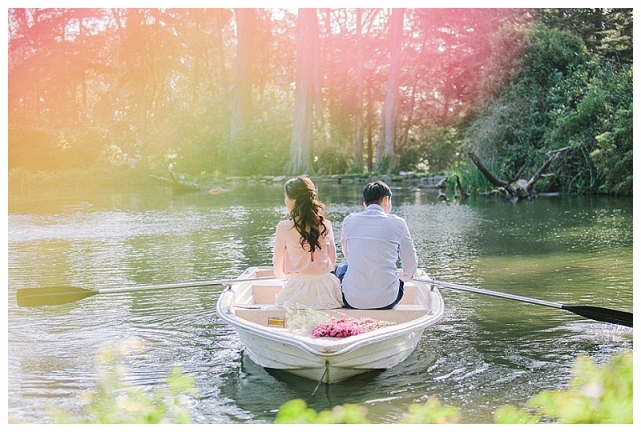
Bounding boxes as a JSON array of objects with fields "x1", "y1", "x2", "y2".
[{"x1": 285, "y1": 9, "x2": 318, "y2": 174}]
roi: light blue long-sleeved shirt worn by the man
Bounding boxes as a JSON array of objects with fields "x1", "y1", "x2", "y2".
[{"x1": 341, "y1": 204, "x2": 418, "y2": 309}]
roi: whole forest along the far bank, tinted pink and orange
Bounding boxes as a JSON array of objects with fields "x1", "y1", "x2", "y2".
[{"x1": 8, "y1": 8, "x2": 633, "y2": 196}]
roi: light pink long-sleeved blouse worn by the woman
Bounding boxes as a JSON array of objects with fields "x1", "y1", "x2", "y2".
[{"x1": 272, "y1": 219, "x2": 336, "y2": 279}]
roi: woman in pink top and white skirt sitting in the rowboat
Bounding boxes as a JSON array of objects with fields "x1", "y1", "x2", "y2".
[{"x1": 272, "y1": 176, "x2": 343, "y2": 309}]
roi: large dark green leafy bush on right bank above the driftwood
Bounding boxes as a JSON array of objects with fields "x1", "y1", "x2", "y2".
[{"x1": 466, "y1": 20, "x2": 633, "y2": 195}]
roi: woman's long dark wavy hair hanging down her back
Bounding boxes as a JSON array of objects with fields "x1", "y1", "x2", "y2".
[{"x1": 285, "y1": 176, "x2": 327, "y2": 253}]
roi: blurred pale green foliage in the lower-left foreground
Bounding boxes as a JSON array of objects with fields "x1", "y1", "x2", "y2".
[{"x1": 51, "y1": 338, "x2": 195, "y2": 424}]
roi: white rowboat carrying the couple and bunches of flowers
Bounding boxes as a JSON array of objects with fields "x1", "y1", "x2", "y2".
[{"x1": 216, "y1": 267, "x2": 444, "y2": 383}]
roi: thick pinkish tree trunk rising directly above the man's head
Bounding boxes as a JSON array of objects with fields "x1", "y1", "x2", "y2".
[{"x1": 376, "y1": 9, "x2": 405, "y2": 173}]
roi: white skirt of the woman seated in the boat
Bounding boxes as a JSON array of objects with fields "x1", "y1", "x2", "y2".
[{"x1": 275, "y1": 273, "x2": 343, "y2": 309}]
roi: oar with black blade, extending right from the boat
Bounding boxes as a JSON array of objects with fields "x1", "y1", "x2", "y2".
[{"x1": 415, "y1": 278, "x2": 632, "y2": 327}]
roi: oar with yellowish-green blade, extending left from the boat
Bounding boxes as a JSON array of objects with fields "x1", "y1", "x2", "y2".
[{"x1": 16, "y1": 276, "x2": 276, "y2": 307}]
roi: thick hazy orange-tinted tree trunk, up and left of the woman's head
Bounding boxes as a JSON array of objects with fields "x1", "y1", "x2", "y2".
[{"x1": 229, "y1": 8, "x2": 256, "y2": 145}]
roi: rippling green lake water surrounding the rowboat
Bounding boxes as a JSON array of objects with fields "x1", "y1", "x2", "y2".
[{"x1": 8, "y1": 183, "x2": 633, "y2": 423}]
